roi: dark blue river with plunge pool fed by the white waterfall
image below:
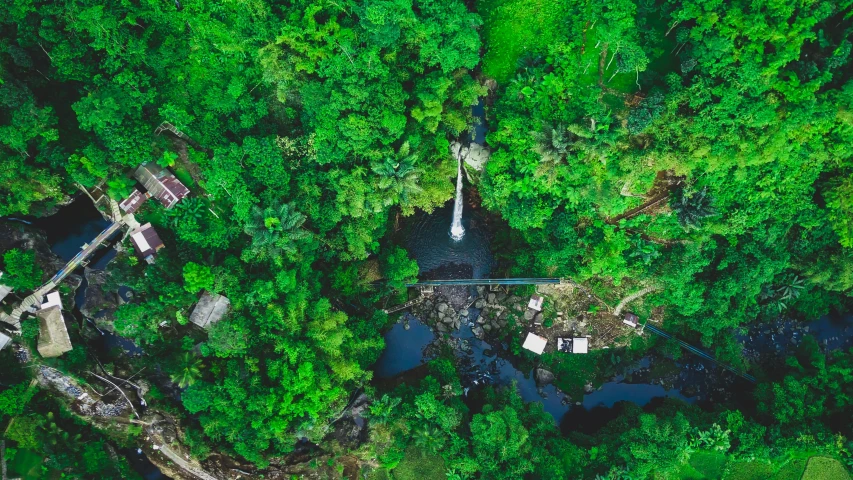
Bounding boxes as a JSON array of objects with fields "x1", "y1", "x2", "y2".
[{"x1": 375, "y1": 101, "x2": 853, "y2": 431}]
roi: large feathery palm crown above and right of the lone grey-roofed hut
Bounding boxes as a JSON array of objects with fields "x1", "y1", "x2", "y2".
[{"x1": 244, "y1": 202, "x2": 311, "y2": 261}]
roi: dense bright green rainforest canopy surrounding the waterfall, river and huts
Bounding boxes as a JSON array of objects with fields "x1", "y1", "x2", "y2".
[{"x1": 0, "y1": 0, "x2": 853, "y2": 480}]
